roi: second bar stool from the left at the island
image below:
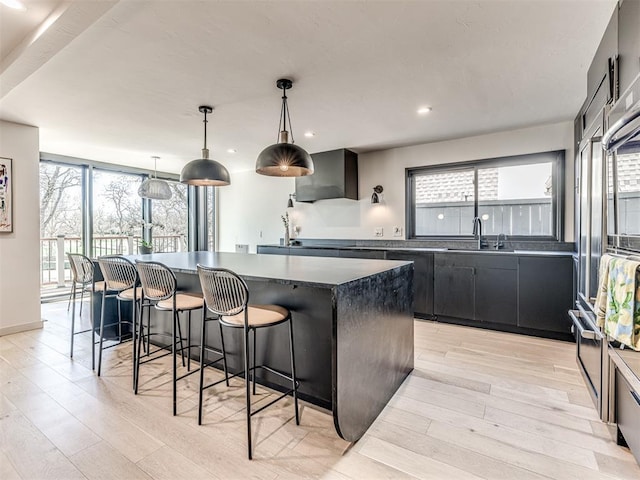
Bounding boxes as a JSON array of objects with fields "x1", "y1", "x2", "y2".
[{"x1": 98, "y1": 255, "x2": 142, "y2": 386}]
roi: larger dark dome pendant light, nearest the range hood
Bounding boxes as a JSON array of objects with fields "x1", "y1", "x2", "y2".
[{"x1": 256, "y1": 78, "x2": 313, "y2": 177}]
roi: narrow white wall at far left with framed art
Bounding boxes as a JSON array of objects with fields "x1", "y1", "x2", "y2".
[{"x1": 0, "y1": 120, "x2": 42, "y2": 335}]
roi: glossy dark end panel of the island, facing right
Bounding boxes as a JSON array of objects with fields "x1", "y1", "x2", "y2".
[{"x1": 333, "y1": 264, "x2": 414, "y2": 441}]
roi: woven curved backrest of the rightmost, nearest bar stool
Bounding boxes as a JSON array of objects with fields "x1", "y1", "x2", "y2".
[{"x1": 198, "y1": 265, "x2": 249, "y2": 316}]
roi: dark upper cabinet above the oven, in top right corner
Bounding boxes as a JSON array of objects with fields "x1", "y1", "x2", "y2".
[{"x1": 618, "y1": 0, "x2": 640, "y2": 94}]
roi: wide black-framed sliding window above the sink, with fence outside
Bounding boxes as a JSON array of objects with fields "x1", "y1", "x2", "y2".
[{"x1": 407, "y1": 152, "x2": 564, "y2": 239}]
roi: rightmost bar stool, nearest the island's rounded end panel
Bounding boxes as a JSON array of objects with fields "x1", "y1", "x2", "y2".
[{"x1": 197, "y1": 265, "x2": 300, "y2": 460}]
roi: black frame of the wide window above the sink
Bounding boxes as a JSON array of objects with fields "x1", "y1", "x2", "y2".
[{"x1": 405, "y1": 150, "x2": 566, "y2": 242}]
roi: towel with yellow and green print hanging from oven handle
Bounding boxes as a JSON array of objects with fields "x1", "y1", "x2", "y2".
[{"x1": 596, "y1": 257, "x2": 640, "y2": 351}]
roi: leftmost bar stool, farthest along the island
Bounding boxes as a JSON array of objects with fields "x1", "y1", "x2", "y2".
[{"x1": 67, "y1": 253, "x2": 104, "y2": 370}]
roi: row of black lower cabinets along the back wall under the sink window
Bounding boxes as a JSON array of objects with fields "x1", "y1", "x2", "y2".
[{"x1": 258, "y1": 246, "x2": 575, "y2": 340}]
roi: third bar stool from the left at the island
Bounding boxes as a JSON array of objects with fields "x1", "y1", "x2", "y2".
[{"x1": 134, "y1": 260, "x2": 204, "y2": 415}]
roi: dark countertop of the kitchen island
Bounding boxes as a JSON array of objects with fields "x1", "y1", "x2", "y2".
[{"x1": 127, "y1": 251, "x2": 411, "y2": 287}]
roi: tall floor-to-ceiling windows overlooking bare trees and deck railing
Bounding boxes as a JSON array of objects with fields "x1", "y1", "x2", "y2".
[{"x1": 40, "y1": 153, "x2": 188, "y2": 297}]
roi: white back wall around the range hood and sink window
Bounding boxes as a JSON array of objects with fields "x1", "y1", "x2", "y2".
[{"x1": 218, "y1": 122, "x2": 574, "y2": 252}]
